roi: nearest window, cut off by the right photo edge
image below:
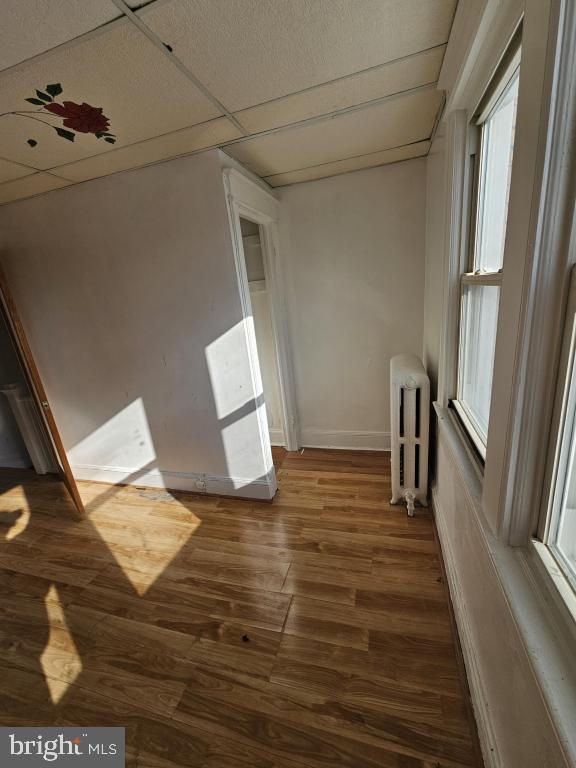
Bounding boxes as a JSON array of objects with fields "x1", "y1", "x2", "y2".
[{"x1": 538, "y1": 268, "x2": 576, "y2": 590}]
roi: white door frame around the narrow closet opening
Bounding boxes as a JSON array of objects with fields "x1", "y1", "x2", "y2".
[{"x1": 223, "y1": 168, "x2": 300, "y2": 451}]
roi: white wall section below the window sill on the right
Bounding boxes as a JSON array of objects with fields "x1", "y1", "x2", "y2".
[{"x1": 434, "y1": 416, "x2": 572, "y2": 768}]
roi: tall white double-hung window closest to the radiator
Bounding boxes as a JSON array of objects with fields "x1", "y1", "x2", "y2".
[{"x1": 453, "y1": 63, "x2": 519, "y2": 458}]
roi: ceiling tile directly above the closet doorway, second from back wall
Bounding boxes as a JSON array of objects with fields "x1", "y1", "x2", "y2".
[{"x1": 226, "y1": 88, "x2": 443, "y2": 176}]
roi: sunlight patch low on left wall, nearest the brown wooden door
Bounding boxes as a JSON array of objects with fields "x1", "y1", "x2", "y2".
[{"x1": 68, "y1": 397, "x2": 156, "y2": 483}]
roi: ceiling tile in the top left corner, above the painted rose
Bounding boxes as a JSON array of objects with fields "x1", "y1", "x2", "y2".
[{"x1": 0, "y1": 0, "x2": 120, "y2": 69}]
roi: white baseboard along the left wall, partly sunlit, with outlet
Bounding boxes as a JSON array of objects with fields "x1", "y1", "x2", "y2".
[{"x1": 72, "y1": 464, "x2": 276, "y2": 501}]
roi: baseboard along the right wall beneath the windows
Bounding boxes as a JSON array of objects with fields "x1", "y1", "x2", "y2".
[{"x1": 431, "y1": 488, "x2": 502, "y2": 768}]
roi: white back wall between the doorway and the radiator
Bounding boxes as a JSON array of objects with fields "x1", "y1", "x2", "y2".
[{"x1": 279, "y1": 159, "x2": 426, "y2": 448}]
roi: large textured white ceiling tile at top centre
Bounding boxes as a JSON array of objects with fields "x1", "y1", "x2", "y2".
[{"x1": 138, "y1": 0, "x2": 457, "y2": 111}]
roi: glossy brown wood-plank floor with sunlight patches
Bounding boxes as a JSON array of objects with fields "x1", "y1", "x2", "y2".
[{"x1": 0, "y1": 450, "x2": 479, "y2": 768}]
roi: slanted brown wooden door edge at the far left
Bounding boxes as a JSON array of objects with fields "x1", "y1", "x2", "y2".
[{"x1": 0, "y1": 264, "x2": 85, "y2": 516}]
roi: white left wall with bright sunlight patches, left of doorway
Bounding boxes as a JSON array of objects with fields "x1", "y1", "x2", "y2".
[{"x1": 0, "y1": 151, "x2": 268, "y2": 495}]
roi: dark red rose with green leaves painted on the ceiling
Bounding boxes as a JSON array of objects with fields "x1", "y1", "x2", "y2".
[{"x1": 0, "y1": 83, "x2": 116, "y2": 148}]
